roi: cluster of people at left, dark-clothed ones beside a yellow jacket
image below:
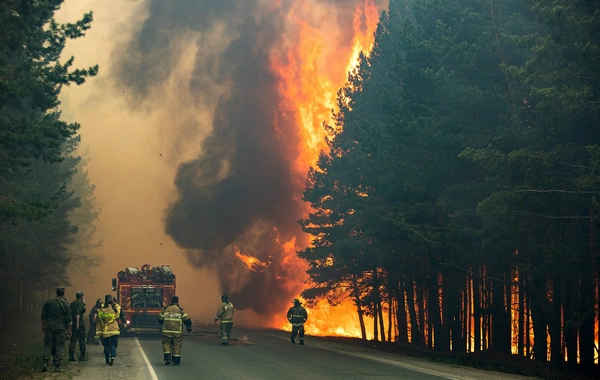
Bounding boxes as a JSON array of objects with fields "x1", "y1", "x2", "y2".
[{"x1": 42, "y1": 286, "x2": 127, "y2": 372}]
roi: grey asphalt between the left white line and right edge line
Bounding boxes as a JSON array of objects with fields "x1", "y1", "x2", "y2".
[{"x1": 137, "y1": 326, "x2": 456, "y2": 380}]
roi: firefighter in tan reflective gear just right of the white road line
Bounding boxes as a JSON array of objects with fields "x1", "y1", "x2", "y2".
[{"x1": 158, "y1": 296, "x2": 192, "y2": 365}]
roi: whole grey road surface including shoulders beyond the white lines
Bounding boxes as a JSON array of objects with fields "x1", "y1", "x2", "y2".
[{"x1": 72, "y1": 325, "x2": 526, "y2": 380}]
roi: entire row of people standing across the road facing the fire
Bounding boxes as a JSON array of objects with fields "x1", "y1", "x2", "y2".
[{"x1": 42, "y1": 286, "x2": 308, "y2": 372}]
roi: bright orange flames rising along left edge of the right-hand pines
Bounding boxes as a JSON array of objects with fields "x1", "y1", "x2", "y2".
[{"x1": 270, "y1": 0, "x2": 379, "y2": 337}]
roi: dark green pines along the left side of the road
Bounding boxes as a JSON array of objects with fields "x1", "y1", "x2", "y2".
[{"x1": 0, "y1": 0, "x2": 100, "y2": 326}]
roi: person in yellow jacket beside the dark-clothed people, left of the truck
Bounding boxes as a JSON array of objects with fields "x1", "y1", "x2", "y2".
[{"x1": 96, "y1": 294, "x2": 127, "y2": 366}]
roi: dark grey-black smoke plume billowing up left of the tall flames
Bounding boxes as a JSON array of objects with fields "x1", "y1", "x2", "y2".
[{"x1": 112, "y1": 0, "x2": 384, "y2": 314}]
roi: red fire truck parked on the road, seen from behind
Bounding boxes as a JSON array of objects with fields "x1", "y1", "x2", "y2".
[{"x1": 112, "y1": 264, "x2": 175, "y2": 328}]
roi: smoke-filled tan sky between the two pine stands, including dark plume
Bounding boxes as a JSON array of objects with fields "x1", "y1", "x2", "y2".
[{"x1": 57, "y1": 0, "x2": 387, "y2": 324}]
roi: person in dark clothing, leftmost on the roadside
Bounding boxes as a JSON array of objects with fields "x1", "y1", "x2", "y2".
[{"x1": 42, "y1": 286, "x2": 73, "y2": 372}]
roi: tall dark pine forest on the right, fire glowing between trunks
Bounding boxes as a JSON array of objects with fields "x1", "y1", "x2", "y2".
[{"x1": 299, "y1": 0, "x2": 600, "y2": 374}]
